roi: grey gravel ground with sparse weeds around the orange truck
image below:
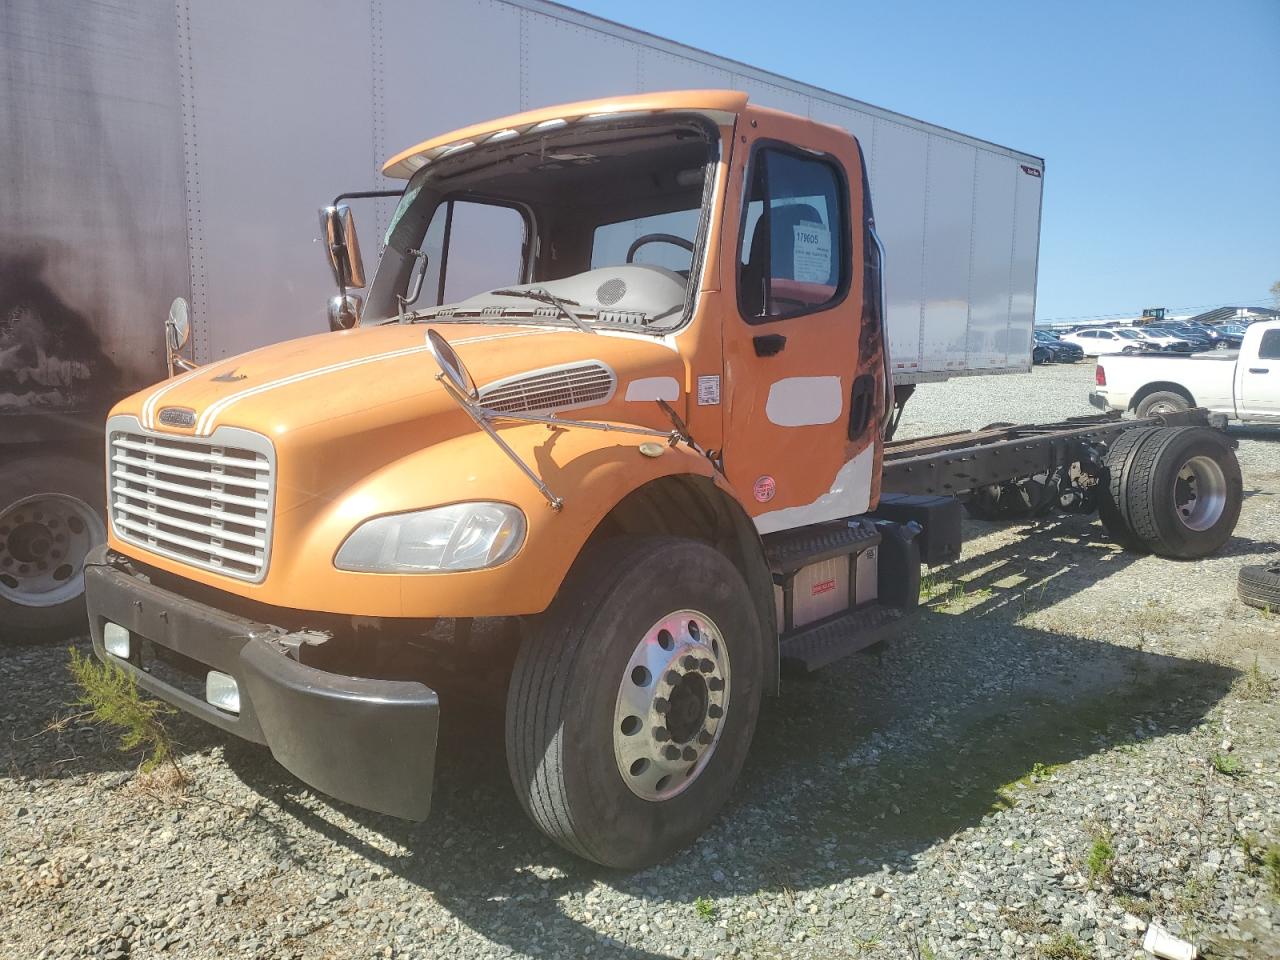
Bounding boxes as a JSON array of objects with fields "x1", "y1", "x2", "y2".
[{"x1": 0, "y1": 364, "x2": 1280, "y2": 960}]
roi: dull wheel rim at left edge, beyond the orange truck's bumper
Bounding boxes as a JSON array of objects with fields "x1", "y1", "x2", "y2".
[{"x1": 0, "y1": 494, "x2": 106, "y2": 607}]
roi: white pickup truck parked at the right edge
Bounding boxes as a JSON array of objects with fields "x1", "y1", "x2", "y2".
[{"x1": 1089, "y1": 320, "x2": 1280, "y2": 425}]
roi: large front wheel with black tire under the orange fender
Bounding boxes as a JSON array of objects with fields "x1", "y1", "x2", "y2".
[{"x1": 507, "y1": 536, "x2": 764, "y2": 869}]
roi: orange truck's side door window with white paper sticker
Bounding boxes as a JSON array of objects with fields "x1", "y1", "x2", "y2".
[{"x1": 737, "y1": 146, "x2": 849, "y2": 323}]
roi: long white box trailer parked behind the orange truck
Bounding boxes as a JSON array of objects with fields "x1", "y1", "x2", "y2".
[{"x1": 0, "y1": 0, "x2": 1043, "y2": 640}]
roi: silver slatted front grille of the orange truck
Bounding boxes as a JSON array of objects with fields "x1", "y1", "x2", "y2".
[{"x1": 108, "y1": 419, "x2": 275, "y2": 581}]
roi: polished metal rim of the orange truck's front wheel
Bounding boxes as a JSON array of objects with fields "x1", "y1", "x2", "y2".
[{"x1": 613, "y1": 611, "x2": 730, "y2": 801}]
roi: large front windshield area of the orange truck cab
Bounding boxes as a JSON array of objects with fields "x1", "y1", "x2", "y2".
[{"x1": 366, "y1": 115, "x2": 717, "y2": 333}]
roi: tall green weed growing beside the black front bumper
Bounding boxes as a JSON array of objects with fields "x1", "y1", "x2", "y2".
[{"x1": 67, "y1": 648, "x2": 182, "y2": 780}]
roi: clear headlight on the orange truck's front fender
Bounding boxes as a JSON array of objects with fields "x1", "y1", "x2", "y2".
[{"x1": 333, "y1": 502, "x2": 525, "y2": 573}]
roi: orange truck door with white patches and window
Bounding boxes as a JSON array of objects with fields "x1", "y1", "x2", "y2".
[{"x1": 716, "y1": 111, "x2": 883, "y2": 532}]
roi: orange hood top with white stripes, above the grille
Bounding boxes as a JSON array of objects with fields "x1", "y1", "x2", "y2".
[{"x1": 113, "y1": 324, "x2": 686, "y2": 513}]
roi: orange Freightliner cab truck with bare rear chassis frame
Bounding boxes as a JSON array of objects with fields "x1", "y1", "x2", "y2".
[{"x1": 86, "y1": 91, "x2": 1242, "y2": 867}]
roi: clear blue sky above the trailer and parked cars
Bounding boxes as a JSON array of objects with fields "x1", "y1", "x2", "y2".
[{"x1": 568, "y1": 0, "x2": 1280, "y2": 320}]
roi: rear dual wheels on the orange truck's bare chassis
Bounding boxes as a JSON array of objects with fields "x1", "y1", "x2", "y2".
[{"x1": 1100, "y1": 426, "x2": 1244, "y2": 559}]
